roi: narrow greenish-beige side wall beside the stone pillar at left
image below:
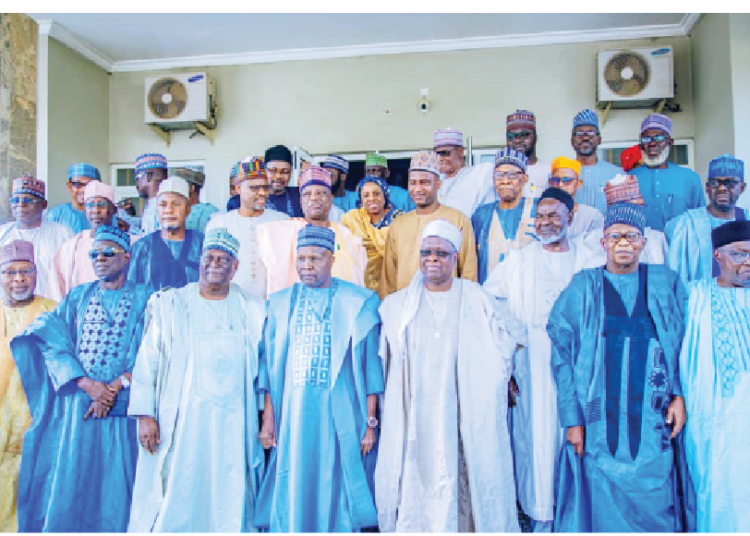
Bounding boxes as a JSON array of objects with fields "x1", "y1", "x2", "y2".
[{"x1": 46, "y1": 38, "x2": 109, "y2": 206}]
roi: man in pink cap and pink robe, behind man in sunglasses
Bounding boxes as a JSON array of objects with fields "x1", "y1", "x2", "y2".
[{"x1": 49, "y1": 181, "x2": 131, "y2": 301}]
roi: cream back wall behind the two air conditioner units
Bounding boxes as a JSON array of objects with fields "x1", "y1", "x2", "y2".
[{"x1": 109, "y1": 37, "x2": 694, "y2": 205}]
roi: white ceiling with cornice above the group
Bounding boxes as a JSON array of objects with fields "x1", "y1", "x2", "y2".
[{"x1": 30, "y1": 13, "x2": 697, "y2": 71}]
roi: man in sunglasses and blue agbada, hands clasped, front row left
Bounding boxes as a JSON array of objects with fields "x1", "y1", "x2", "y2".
[{"x1": 11, "y1": 225, "x2": 149, "y2": 532}]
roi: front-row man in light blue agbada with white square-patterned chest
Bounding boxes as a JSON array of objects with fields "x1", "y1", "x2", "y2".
[{"x1": 255, "y1": 225, "x2": 384, "y2": 532}]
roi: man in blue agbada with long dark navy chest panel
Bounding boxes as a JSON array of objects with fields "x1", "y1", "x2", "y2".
[{"x1": 547, "y1": 203, "x2": 686, "y2": 532}]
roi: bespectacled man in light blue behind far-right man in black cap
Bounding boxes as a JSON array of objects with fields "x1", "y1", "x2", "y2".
[{"x1": 664, "y1": 154, "x2": 750, "y2": 284}]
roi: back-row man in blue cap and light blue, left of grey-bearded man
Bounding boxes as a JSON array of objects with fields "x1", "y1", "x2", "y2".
[{"x1": 570, "y1": 109, "x2": 622, "y2": 214}]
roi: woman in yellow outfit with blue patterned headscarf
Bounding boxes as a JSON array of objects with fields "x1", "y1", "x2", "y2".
[{"x1": 341, "y1": 175, "x2": 403, "y2": 292}]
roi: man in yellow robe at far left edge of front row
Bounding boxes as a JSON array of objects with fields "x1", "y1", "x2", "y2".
[{"x1": 0, "y1": 240, "x2": 57, "y2": 532}]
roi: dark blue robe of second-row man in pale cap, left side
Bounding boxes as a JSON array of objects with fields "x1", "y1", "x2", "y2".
[{"x1": 128, "y1": 229, "x2": 203, "y2": 291}]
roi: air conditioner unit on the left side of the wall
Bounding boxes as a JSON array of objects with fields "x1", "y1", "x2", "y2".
[{"x1": 145, "y1": 73, "x2": 215, "y2": 126}]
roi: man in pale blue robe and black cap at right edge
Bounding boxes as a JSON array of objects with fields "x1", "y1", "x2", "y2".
[{"x1": 680, "y1": 221, "x2": 750, "y2": 532}]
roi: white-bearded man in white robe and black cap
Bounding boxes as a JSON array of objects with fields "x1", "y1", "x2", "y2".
[{"x1": 484, "y1": 188, "x2": 598, "y2": 532}]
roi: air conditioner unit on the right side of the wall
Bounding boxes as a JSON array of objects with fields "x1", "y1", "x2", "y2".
[{"x1": 596, "y1": 47, "x2": 674, "y2": 108}]
